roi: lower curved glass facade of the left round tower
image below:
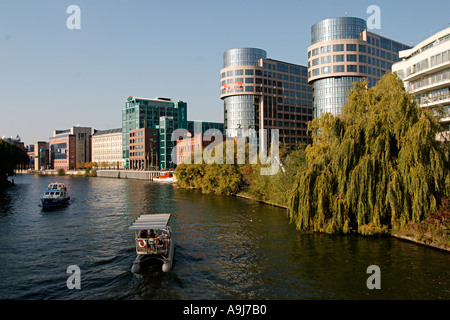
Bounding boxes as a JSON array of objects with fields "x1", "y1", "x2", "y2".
[{"x1": 224, "y1": 95, "x2": 255, "y2": 137}]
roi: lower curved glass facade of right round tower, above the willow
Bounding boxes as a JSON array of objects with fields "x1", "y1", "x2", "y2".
[{"x1": 314, "y1": 77, "x2": 361, "y2": 118}]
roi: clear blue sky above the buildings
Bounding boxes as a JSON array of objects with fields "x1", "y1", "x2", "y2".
[{"x1": 0, "y1": 0, "x2": 450, "y2": 144}]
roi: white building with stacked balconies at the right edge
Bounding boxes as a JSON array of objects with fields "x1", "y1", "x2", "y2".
[{"x1": 392, "y1": 27, "x2": 450, "y2": 138}]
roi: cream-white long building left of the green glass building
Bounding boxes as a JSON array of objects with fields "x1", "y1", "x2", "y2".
[{"x1": 92, "y1": 128, "x2": 125, "y2": 168}]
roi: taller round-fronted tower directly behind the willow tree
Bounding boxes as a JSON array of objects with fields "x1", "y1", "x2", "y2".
[{"x1": 308, "y1": 17, "x2": 409, "y2": 117}]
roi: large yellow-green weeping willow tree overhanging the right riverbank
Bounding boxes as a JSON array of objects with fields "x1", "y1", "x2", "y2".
[{"x1": 288, "y1": 74, "x2": 450, "y2": 234}]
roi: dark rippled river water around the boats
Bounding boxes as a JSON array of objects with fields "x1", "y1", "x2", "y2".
[{"x1": 0, "y1": 175, "x2": 450, "y2": 300}]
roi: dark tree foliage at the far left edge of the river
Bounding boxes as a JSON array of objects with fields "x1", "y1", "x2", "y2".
[{"x1": 0, "y1": 139, "x2": 29, "y2": 185}]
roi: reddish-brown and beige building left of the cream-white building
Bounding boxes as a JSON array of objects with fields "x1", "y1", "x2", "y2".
[{"x1": 49, "y1": 126, "x2": 92, "y2": 170}]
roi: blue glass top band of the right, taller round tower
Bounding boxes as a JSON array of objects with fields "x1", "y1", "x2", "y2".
[{"x1": 311, "y1": 17, "x2": 367, "y2": 44}]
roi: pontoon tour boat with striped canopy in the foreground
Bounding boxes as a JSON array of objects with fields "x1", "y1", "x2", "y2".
[{"x1": 129, "y1": 213, "x2": 175, "y2": 273}]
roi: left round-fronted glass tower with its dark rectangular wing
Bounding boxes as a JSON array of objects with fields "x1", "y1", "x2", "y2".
[{"x1": 220, "y1": 48, "x2": 313, "y2": 146}]
